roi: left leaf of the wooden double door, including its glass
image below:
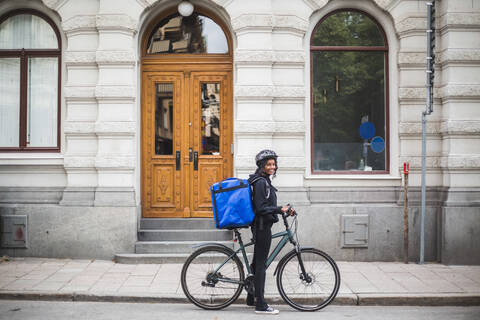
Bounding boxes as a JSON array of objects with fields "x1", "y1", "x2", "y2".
[{"x1": 142, "y1": 73, "x2": 187, "y2": 217}]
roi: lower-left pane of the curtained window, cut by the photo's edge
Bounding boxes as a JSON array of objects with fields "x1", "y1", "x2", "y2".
[{"x1": 0, "y1": 58, "x2": 20, "y2": 147}]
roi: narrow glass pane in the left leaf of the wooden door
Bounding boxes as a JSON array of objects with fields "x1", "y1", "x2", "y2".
[{"x1": 155, "y1": 83, "x2": 173, "y2": 155}]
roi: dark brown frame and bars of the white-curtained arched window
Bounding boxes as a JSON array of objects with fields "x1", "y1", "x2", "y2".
[{"x1": 0, "y1": 9, "x2": 62, "y2": 152}]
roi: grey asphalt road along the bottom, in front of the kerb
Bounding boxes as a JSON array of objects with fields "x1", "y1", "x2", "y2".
[{"x1": 0, "y1": 300, "x2": 480, "y2": 320}]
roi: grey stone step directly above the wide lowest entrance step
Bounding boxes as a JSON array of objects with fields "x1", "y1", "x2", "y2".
[{"x1": 135, "y1": 241, "x2": 233, "y2": 254}]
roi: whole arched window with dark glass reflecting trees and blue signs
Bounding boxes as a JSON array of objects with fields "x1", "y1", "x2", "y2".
[{"x1": 310, "y1": 9, "x2": 388, "y2": 174}]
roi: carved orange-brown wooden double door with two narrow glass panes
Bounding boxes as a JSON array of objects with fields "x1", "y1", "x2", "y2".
[{"x1": 142, "y1": 65, "x2": 233, "y2": 217}]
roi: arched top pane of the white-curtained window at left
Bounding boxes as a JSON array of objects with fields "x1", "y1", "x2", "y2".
[{"x1": 0, "y1": 14, "x2": 58, "y2": 49}]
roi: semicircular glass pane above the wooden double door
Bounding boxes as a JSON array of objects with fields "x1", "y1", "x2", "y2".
[{"x1": 147, "y1": 13, "x2": 228, "y2": 53}]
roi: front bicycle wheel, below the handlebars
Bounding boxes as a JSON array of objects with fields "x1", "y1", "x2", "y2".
[{"x1": 277, "y1": 249, "x2": 340, "y2": 311}]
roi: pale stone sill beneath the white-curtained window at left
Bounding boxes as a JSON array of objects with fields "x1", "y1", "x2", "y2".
[{"x1": 0, "y1": 152, "x2": 63, "y2": 166}]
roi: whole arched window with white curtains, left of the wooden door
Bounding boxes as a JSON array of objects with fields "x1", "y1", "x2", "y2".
[{"x1": 0, "y1": 10, "x2": 61, "y2": 151}]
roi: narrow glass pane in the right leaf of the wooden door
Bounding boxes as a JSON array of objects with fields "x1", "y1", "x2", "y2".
[{"x1": 201, "y1": 83, "x2": 220, "y2": 155}]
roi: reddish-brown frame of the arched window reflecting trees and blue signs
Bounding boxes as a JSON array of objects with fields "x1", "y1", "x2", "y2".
[{"x1": 309, "y1": 8, "x2": 390, "y2": 176}]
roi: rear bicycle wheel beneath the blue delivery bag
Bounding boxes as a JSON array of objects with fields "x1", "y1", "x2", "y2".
[{"x1": 181, "y1": 246, "x2": 245, "y2": 310}]
